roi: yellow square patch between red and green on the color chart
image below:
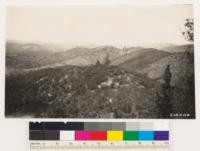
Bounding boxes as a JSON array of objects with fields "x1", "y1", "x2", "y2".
[{"x1": 107, "y1": 131, "x2": 123, "y2": 141}]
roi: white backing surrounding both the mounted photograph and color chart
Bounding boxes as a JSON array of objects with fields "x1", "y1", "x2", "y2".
[{"x1": 0, "y1": 0, "x2": 200, "y2": 151}]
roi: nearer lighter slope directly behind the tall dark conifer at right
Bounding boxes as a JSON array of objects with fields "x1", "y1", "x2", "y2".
[{"x1": 136, "y1": 52, "x2": 194, "y2": 85}]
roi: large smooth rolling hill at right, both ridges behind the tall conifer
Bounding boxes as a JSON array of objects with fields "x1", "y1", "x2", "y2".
[{"x1": 114, "y1": 45, "x2": 194, "y2": 88}]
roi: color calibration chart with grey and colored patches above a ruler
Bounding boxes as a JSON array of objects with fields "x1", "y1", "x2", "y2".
[{"x1": 29, "y1": 121, "x2": 170, "y2": 151}]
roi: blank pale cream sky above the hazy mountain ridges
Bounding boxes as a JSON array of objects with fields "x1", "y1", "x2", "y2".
[{"x1": 6, "y1": 4, "x2": 193, "y2": 47}]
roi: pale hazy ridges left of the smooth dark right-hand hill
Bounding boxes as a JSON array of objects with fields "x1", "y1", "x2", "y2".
[{"x1": 6, "y1": 42, "x2": 143, "y2": 69}]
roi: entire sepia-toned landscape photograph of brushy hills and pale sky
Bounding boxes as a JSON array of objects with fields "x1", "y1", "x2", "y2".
[{"x1": 5, "y1": 4, "x2": 195, "y2": 119}]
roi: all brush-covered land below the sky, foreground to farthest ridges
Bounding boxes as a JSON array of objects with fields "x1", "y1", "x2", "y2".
[{"x1": 6, "y1": 42, "x2": 195, "y2": 118}]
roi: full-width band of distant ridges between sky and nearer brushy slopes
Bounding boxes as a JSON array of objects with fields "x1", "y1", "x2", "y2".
[{"x1": 6, "y1": 42, "x2": 193, "y2": 71}]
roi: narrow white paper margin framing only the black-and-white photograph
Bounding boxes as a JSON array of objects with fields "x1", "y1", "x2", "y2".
[{"x1": 0, "y1": 0, "x2": 199, "y2": 121}]
